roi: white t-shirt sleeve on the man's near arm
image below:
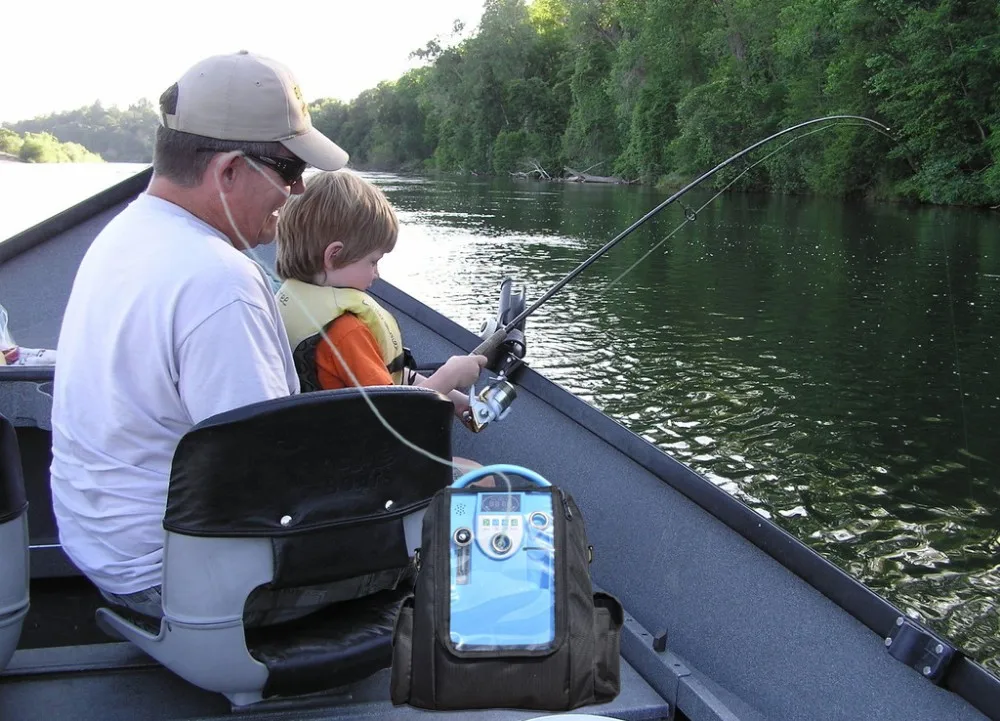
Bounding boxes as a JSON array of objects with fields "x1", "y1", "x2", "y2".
[{"x1": 177, "y1": 300, "x2": 293, "y2": 423}]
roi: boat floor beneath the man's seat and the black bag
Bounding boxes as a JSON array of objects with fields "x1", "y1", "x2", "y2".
[{"x1": 0, "y1": 578, "x2": 669, "y2": 721}]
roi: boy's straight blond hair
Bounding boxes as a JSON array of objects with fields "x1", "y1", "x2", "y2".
[{"x1": 275, "y1": 170, "x2": 399, "y2": 283}]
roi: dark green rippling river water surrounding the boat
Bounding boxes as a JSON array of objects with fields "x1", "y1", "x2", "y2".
[{"x1": 0, "y1": 163, "x2": 1000, "y2": 673}]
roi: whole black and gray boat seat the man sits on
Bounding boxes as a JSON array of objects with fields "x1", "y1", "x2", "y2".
[{"x1": 97, "y1": 386, "x2": 454, "y2": 706}]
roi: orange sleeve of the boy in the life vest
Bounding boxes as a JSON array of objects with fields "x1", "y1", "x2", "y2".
[{"x1": 316, "y1": 313, "x2": 392, "y2": 389}]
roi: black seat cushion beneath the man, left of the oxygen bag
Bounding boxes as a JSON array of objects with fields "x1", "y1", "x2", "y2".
[{"x1": 246, "y1": 583, "x2": 412, "y2": 698}]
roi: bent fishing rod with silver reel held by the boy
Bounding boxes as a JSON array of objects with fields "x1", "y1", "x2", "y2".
[{"x1": 466, "y1": 115, "x2": 892, "y2": 432}]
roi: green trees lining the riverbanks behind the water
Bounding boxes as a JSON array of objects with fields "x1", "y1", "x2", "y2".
[{"x1": 3, "y1": 0, "x2": 1000, "y2": 206}]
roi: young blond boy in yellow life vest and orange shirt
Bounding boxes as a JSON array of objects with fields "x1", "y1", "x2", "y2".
[{"x1": 276, "y1": 170, "x2": 486, "y2": 473}]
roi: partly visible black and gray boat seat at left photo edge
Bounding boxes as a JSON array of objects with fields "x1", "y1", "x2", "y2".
[{"x1": 0, "y1": 415, "x2": 28, "y2": 671}]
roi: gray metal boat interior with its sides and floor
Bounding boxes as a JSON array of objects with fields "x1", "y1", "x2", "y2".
[{"x1": 0, "y1": 171, "x2": 1000, "y2": 721}]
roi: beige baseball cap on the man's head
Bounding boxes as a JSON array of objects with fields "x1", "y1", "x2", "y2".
[{"x1": 161, "y1": 50, "x2": 348, "y2": 170}]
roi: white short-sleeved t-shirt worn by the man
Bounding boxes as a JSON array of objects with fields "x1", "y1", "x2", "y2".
[{"x1": 51, "y1": 193, "x2": 299, "y2": 594}]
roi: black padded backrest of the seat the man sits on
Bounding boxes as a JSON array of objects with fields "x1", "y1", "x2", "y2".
[{"x1": 163, "y1": 386, "x2": 454, "y2": 588}]
